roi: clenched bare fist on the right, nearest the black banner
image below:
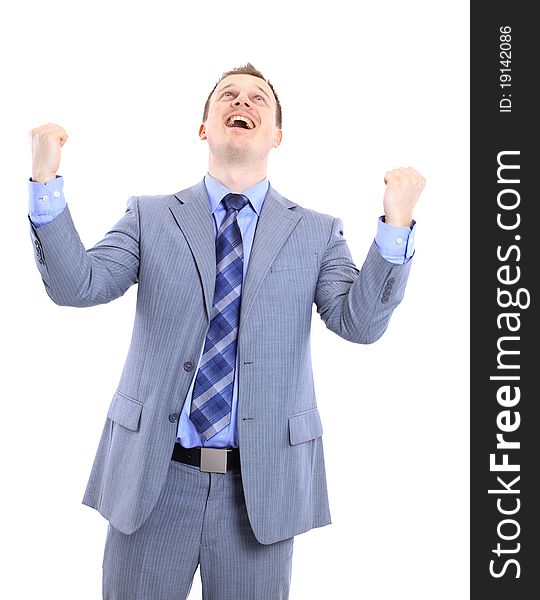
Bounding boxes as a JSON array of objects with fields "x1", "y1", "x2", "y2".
[{"x1": 383, "y1": 167, "x2": 426, "y2": 227}]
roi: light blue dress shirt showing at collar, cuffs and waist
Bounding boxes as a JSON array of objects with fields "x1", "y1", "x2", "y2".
[{"x1": 28, "y1": 173, "x2": 416, "y2": 448}]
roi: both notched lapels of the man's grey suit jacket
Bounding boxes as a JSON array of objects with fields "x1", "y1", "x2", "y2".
[{"x1": 169, "y1": 181, "x2": 301, "y2": 333}]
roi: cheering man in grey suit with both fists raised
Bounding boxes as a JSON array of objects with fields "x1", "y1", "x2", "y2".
[{"x1": 29, "y1": 63, "x2": 424, "y2": 600}]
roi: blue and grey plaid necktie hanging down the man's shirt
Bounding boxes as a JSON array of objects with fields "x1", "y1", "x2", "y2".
[{"x1": 189, "y1": 194, "x2": 248, "y2": 440}]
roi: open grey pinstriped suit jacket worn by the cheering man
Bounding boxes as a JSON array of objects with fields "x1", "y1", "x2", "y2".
[{"x1": 31, "y1": 182, "x2": 411, "y2": 544}]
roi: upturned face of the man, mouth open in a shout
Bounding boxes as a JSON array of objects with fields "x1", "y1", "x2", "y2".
[{"x1": 199, "y1": 75, "x2": 281, "y2": 161}]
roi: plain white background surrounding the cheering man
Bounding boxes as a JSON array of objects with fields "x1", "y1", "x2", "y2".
[{"x1": 0, "y1": 0, "x2": 469, "y2": 600}]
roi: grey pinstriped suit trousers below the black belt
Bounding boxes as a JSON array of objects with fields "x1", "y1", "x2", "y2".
[{"x1": 103, "y1": 460, "x2": 294, "y2": 600}]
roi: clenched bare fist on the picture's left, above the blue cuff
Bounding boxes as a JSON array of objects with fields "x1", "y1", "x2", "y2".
[{"x1": 30, "y1": 123, "x2": 67, "y2": 183}]
